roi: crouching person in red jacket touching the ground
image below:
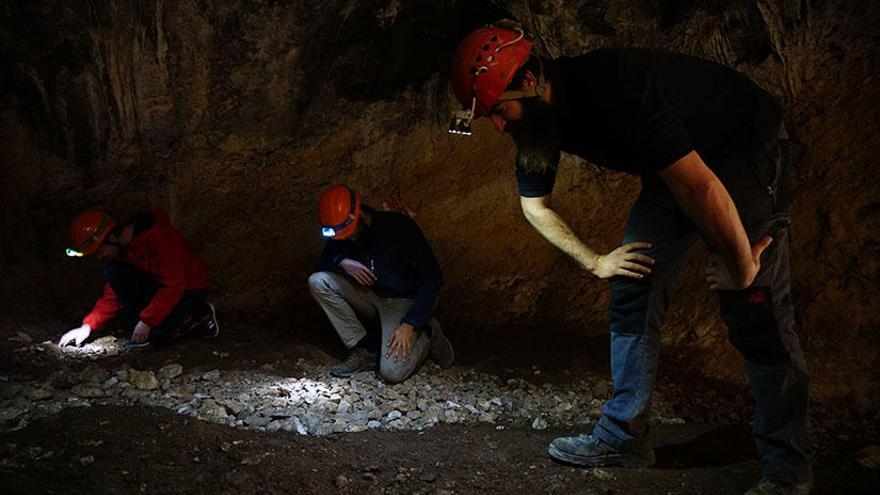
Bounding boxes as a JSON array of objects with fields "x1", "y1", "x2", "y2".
[{"x1": 58, "y1": 209, "x2": 220, "y2": 347}]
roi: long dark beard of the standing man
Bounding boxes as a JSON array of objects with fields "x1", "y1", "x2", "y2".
[{"x1": 505, "y1": 98, "x2": 562, "y2": 173}]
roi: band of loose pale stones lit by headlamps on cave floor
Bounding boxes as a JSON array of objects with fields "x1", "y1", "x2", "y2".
[{"x1": 0, "y1": 360, "x2": 682, "y2": 435}]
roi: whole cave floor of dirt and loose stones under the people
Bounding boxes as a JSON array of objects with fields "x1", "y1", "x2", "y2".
[{"x1": 0, "y1": 324, "x2": 880, "y2": 494}]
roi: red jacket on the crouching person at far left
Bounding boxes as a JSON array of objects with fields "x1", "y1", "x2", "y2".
[{"x1": 83, "y1": 208, "x2": 209, "y2": 331}]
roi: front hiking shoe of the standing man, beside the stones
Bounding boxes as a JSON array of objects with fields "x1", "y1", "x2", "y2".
[{"x1": 547, "y1": 435, "x2": 654, "y2": 467}]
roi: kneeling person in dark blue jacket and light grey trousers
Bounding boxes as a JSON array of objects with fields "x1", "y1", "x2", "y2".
[{"x1": 309, "y1": 185, "x2": 453, "y2": 383}]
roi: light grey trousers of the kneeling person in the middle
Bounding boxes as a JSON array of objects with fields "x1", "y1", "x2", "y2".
[{"x1": 309, "y1": 272, "x2": 431, "y2": 383}]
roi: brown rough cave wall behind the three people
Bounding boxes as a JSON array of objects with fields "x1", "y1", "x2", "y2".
[{"x1": 0, "y1": 0, "x2": 880, "y2": 406}]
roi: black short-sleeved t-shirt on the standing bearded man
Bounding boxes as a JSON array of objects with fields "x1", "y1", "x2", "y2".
[{"x1": 516, "y1": 48, "x2": 782, "y2": 197}]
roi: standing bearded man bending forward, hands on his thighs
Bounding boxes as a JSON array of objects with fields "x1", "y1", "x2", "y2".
[{"x1": 450, "y1": 23, "x2": 813, "y2": 495}]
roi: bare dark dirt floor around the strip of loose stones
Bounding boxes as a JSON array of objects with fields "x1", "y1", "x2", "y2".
[{"x1": 0, "y1": 324, "x2": 880, "y2": 495}]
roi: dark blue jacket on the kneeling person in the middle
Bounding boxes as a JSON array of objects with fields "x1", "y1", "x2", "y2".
[{"x1": 315, "y1": 210, "x2": 442, "y2": 328}]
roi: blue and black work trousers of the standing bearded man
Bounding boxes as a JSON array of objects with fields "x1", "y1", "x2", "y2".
[{"x1": 593, "y1": 129, "x2": 814, "y2": 483}]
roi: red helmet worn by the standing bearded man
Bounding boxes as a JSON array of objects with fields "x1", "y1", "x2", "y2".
[{"x1": 451, "y1": 27, "x2": 533, "y2": 118}]
